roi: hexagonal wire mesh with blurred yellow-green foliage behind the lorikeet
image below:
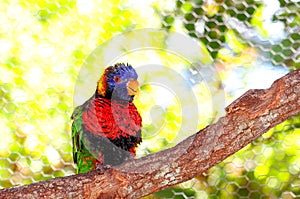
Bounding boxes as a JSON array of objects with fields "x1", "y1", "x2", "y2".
[{"x1": 0, "y1": 0, "x2": 300, "y2": 199}]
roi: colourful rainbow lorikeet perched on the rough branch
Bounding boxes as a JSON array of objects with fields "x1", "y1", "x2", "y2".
[{"x1": 72, "y1": 63, "x2": 142, "y2": 173}]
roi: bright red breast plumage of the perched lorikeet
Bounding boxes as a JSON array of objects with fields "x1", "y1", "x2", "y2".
[{"x1": 82, "y1": 98, "x2": 142, "y2": 139}]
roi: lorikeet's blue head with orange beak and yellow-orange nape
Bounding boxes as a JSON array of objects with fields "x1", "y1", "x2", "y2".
[{"x1": 96, "y1": 63, "x2": 139, "y2": 102}]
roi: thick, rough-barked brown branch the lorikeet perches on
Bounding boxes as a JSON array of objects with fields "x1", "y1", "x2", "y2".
[{"x1": 0, "y1": 70, "x2": 300, "y2": 199}]
